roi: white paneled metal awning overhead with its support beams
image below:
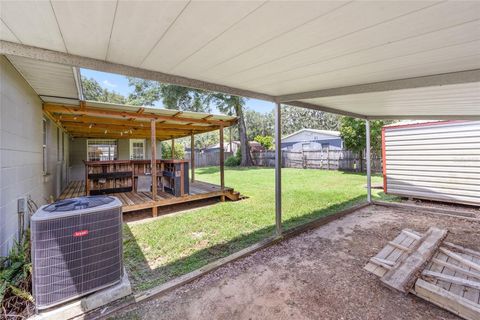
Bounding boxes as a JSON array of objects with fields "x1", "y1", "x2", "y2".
[{"x1": 0, "y1": 1, "x2": 480, "y2": 118}]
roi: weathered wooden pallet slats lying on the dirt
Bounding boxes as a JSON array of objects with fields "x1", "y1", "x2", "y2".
[{"x1": 365, "y1": 229, "x2": 480, "y2": 320}]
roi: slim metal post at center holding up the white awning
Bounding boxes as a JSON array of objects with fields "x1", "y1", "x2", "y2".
[{"x1": 275, "y1": 102, "x2": 282, "y2": 236}]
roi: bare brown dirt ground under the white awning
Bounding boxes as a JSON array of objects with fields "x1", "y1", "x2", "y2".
[{"x1": 110, "y1": 206, "x2": 480, "y2": 320}]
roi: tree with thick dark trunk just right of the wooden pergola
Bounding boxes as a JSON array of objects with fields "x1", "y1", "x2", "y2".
[{"x1": 208, "y1": 93, "x2": 253, "y2": 167}]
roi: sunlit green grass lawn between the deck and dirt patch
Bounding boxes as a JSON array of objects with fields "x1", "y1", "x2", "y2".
[{"x1": 124, "y1": 168, "x2": 390, "y2": 290}]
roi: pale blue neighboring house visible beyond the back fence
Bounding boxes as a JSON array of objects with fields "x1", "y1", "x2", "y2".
[{"x1": 282, "y1": 129, "x2": 343, "y2": 151}]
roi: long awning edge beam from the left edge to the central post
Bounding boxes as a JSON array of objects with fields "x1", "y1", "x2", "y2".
[{"x1": 0, "y1": 40, "x2": 273, "y2": 102}]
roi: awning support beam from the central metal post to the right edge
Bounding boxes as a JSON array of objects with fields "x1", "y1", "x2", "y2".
[{"x1": 277, "y1": 69, "x2": 480, "y2": 104}]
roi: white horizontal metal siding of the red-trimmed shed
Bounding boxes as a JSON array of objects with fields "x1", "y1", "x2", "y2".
[{"x1": 384, "y1": 121, "x2": 480, "y2": 205}]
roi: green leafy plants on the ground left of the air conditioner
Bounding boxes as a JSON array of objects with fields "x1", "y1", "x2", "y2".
[{"x1": 0, "y1": 231, "x2": 34, "y2": 319}]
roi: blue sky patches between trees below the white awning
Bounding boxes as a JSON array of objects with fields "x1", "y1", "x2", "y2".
[{"x1": 80, "y1": 69, "x2": 274, "y2": 113}]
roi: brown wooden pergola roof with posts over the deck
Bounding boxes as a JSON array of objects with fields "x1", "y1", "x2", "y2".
[{"x1": 43, "y1": 101, "x2": 237, "y2": 215}]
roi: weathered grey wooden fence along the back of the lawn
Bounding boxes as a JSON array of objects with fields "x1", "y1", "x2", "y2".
[{"x1": 252, "y1": 149, "x2": 382, "y2": 172}]
